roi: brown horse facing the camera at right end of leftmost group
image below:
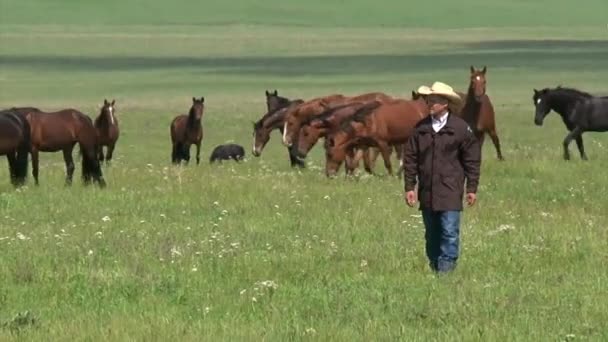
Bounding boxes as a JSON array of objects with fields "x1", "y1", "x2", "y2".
[{"x1": 95, "y1": 99, "x2": 120, "y2": 164}]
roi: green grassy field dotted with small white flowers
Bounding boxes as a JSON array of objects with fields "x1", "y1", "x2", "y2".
[{"x1": 0, "y1": 0, "x2": 608, "y2": 341}]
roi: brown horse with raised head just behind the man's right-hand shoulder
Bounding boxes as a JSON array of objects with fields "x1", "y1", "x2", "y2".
[{"x1": 460, "y1": 66, "x2": 504, "y2": 160}]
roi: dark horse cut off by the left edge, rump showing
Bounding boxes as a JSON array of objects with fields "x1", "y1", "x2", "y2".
[{"x1": 0, "y1": 109, "x2": 31, "y2": 187}]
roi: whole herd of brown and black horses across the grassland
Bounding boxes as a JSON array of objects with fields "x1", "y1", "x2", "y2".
[{"x1": 0, "y1": 66, "x2": 608, "y2": 187}]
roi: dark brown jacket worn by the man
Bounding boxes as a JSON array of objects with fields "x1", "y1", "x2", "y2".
[{"x1": 403, "y1": 114, "x2": 481, "y2": 211}]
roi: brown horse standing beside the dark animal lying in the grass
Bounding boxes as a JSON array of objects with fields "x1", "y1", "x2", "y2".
[{"x1": 170, "y1": 97, "x2": 205, "y2": 165}]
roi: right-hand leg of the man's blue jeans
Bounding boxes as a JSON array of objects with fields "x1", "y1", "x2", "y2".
[{"x1": 437, "y1": 211, "x2": 460, "y2": 272}]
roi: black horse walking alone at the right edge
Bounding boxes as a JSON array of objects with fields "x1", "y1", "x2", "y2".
[{"x1": 532, "y1": 86, "x2": 608, "y2": 160}]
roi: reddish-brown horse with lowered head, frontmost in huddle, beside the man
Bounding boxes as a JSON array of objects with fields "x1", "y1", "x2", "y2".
[{"x1": 325, "y1": 99, "x2": 428, "y2": 176}]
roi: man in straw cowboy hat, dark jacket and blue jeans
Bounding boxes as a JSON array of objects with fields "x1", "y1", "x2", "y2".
[{"x1": 403, "y1": 82, "x2": 481, "y2": 273}]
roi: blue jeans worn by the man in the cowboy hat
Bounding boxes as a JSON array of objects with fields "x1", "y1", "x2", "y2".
[{"x1": 422, "y1": 209, "x2": 460, "y2": 272}]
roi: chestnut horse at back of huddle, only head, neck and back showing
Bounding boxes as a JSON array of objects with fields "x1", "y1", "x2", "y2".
[{"x1": 283, "y1": 93, "x2": 392, "y2": 146}]
